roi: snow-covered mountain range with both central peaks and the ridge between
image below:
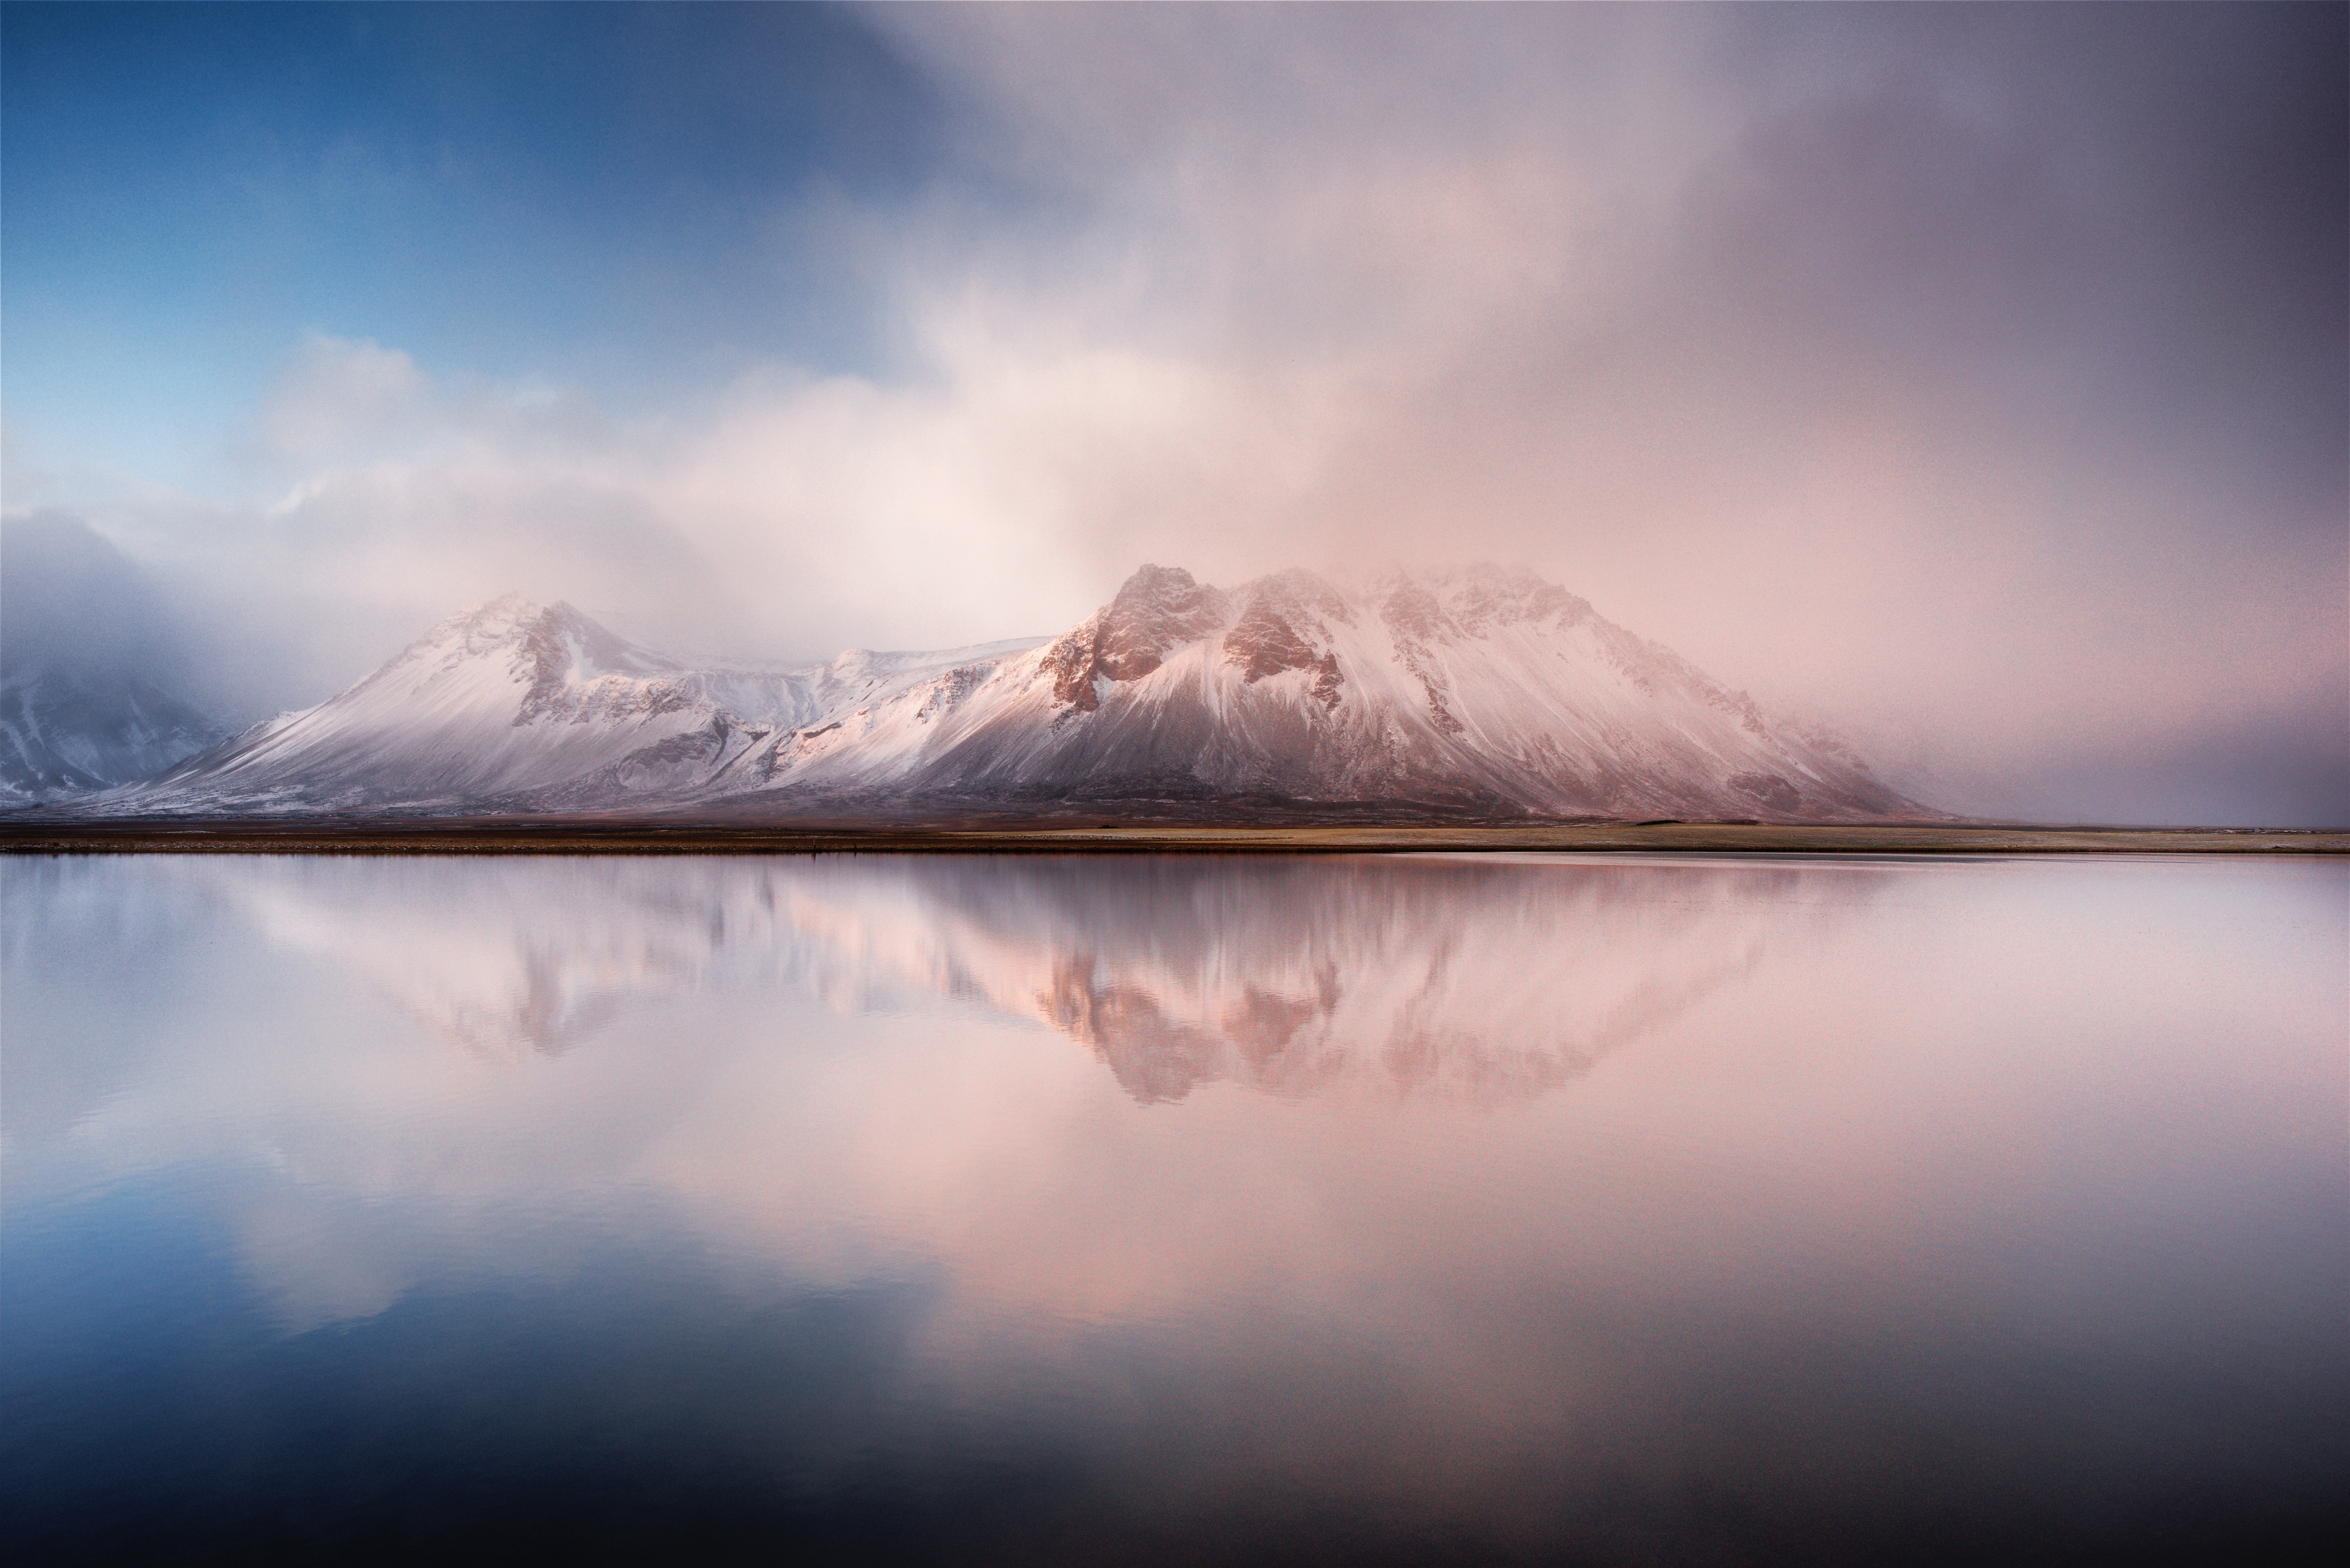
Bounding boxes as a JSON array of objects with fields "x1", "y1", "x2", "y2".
[{"x1": 64, "y1": 566, "x2": 1934, "y2": 820}]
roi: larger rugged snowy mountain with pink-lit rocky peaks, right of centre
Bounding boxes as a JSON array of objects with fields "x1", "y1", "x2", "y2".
[{"x1": 747, "y1": 566, "x2": 1922, "y2": 820}]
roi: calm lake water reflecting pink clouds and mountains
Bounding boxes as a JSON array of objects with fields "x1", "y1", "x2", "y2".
[{"x1": 0, "y1": 856, "x2": 2350, "y2": 1563}]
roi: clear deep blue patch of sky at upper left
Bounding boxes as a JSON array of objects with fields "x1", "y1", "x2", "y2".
[{"x1": 0, "y1": 5, "x2": 947, "y2": 479}]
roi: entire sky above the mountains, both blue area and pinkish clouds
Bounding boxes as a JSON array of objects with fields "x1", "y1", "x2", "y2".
[{"x1": 0, "y1": 2, "x2": 2350, "y2": 825}]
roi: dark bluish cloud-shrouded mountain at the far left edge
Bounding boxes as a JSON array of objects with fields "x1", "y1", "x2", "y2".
[{"x1": 0, "y1": 512, "x2": 233, "y2": 804}]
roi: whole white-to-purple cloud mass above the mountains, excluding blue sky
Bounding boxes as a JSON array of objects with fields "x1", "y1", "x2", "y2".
[{"x1": 5, "y1": 5, "x2": 2350, "y2": 825}]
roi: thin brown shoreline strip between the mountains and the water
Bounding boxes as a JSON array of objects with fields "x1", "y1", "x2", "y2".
[{"x1": 0, "y1": 818, "x2": 2350, "y2": 856}]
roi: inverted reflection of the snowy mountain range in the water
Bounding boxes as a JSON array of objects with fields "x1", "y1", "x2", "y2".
[{"x1": 188, "y1": 856, "x2": 1880, "y2": 1102}]
